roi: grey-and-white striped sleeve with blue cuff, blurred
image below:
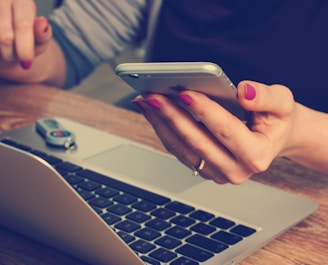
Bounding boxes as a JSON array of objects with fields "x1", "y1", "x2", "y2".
[{"x1": 49, "y1": 0, "x2": 149, "y2": 88}]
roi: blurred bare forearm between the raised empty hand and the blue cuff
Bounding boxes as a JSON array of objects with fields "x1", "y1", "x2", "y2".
[{"x1": 1, "y1": 40, "x2": 66, "y2": 87}]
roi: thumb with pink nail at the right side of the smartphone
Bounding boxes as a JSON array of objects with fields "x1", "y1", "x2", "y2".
[{"x1": 238, "y1": 80, "x2": 294, "y2": 116}]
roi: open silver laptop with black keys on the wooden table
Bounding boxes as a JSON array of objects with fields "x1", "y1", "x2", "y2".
[{"x1": 0, "y1": 118, "x2": 318, "y2": 265}]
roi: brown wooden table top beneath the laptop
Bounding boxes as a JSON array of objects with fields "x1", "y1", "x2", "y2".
[{"x1": 0, "y1": 84, "x2": 328, "y2": 265}]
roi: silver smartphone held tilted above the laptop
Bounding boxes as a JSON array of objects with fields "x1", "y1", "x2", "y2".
[{"x1": 115, "y1": 62, "x2": 248, "y2": 121}]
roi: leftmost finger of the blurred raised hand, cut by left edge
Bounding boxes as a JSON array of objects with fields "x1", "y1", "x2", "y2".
[{"x1": 0, "y1": 1, "x2": 15, "y2": 62}]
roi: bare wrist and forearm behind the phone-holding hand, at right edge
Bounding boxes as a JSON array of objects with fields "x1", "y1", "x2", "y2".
[{"x1": 286, "y1": 104, "x2": 328, "y2": 173}]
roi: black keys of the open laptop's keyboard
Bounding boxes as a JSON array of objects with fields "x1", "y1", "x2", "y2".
[{"x1": 1, "y1": 139, "x2": 256, "y2": 265}]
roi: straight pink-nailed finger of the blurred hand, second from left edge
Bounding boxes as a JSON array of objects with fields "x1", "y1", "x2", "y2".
[{"x1": 13, "y1": 0, "x2": 36, "y2": 62}]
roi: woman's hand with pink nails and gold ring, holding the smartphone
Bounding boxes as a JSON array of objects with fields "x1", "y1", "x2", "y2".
[{"x1": 133, "y1": 81, "x2": 298, "y2": 184}]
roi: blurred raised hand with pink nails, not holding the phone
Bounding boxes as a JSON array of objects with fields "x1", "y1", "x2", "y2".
[{"x1": 0, "y1": 0, "x2": 52, "y2": 74}]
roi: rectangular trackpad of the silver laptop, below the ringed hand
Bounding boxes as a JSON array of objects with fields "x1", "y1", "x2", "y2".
[{"x1": 86, "y1": 144, "x2": 204, "y2": 193}]
